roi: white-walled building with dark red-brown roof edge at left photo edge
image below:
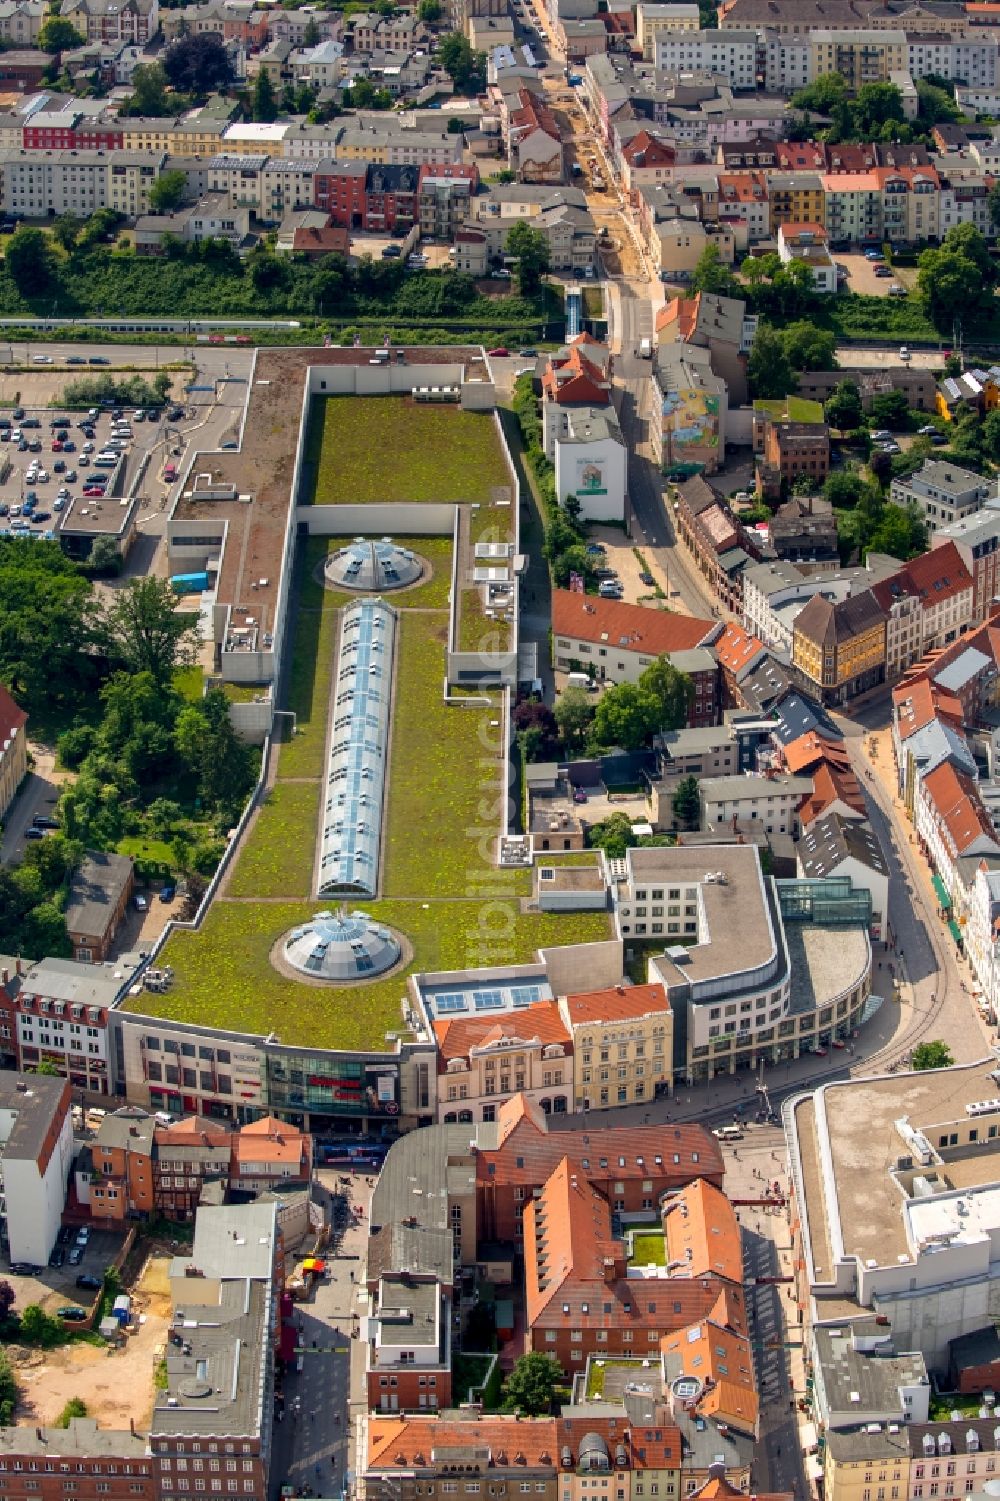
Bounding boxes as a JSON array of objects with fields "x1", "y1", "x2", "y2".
[{"x1": 0, "y1": 1072, "x2": 74, "y2": 1267}]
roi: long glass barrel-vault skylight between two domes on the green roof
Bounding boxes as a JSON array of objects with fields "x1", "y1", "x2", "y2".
[{"x1": 317, "y1": 599, "x2": 396, "y2": 896}]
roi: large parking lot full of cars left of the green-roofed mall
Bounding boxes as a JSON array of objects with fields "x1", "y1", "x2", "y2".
[{"x1": 0, "y1": 407, "x2": 183, "y2": 536}]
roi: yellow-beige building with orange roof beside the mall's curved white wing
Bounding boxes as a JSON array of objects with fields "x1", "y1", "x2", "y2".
[{"x1": 559, "y1": 985, "x2": 674, "y2": 1111}]
